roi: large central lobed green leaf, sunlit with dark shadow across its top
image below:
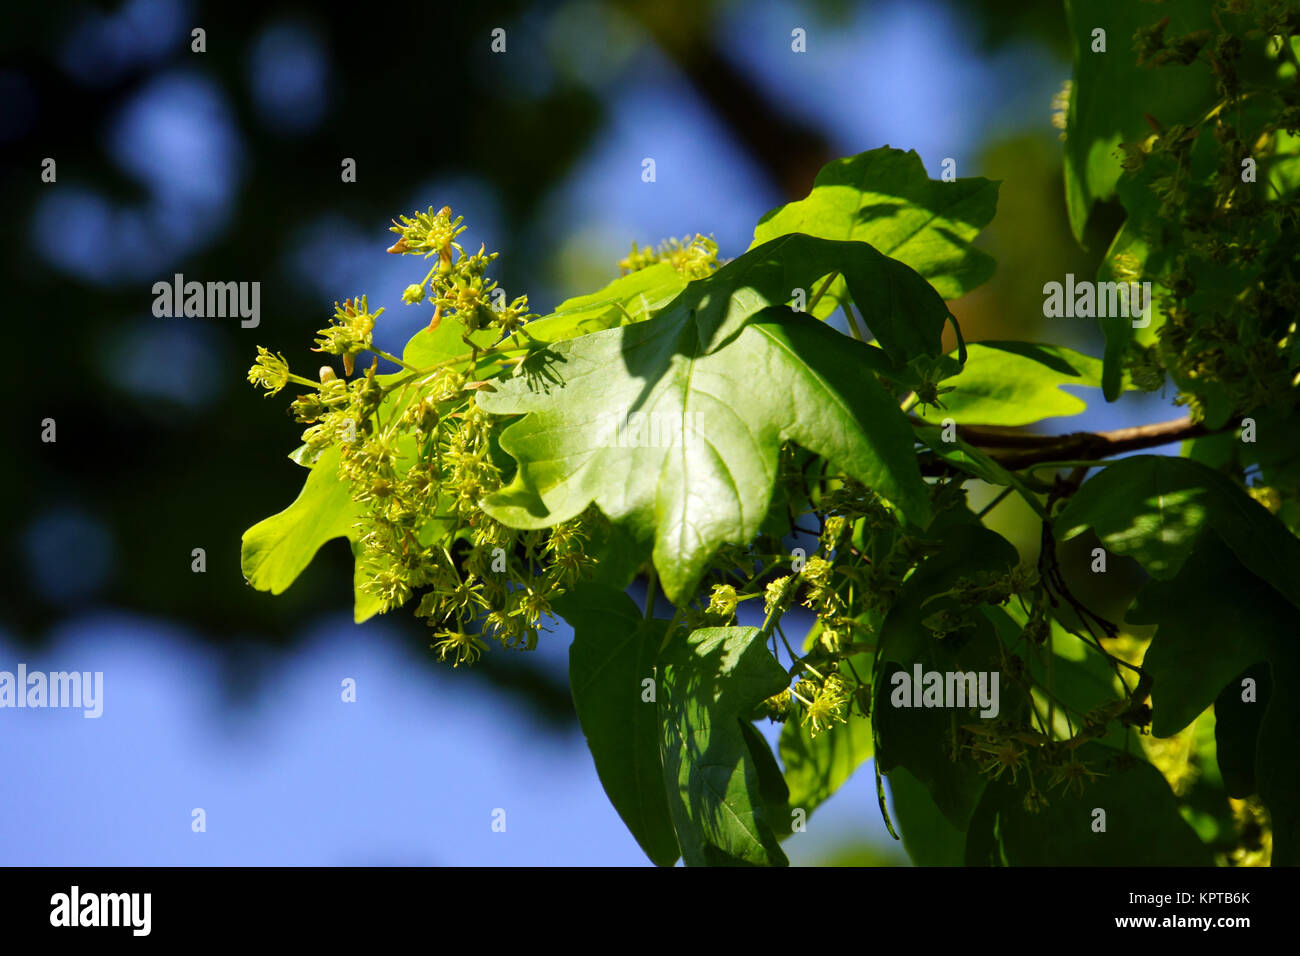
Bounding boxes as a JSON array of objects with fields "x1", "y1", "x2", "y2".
[{"x1": 480, "y1": 235, "x2": 946, "y2": 604}]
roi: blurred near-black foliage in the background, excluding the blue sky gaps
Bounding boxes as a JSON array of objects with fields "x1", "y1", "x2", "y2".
[{"x1": 0, "y1": 0, "x2": 1061, "y2": 722}]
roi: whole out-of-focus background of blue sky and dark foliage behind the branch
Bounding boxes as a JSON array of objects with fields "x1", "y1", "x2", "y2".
[{"x1": 0, "y1": 0, "x2": 1167, "y2": 865}]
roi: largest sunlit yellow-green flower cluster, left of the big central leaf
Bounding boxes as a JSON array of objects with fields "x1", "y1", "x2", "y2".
[{"x1": 248, "y1": 208, "x2": 603, "y2": 666}]
